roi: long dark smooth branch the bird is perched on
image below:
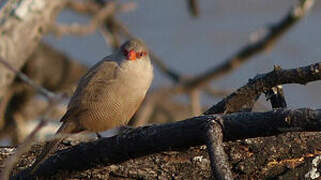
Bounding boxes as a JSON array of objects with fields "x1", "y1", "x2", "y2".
[{"x1": 18, "y1": 109, "x2": 321, "y2": 177}]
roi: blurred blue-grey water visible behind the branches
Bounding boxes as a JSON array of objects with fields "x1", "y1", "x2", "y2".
[{"x1": 42, "y1": 0, "x2": 321, "y2": 108}]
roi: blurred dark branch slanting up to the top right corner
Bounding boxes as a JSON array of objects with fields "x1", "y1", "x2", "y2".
[{"x1": 177, "y1": 0, "x2": 314, "y2": 91}]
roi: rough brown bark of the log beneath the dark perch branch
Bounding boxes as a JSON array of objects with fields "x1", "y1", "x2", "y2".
[{"x1": 0, "y1": 133, "x2": 321, "y2": 179}]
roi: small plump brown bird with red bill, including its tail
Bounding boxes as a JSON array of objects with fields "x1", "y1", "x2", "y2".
[{"x1": 31, "y1": 39, "x2": 153, "y2": 174}]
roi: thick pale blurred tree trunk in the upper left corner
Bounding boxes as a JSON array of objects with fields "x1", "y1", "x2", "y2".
[{"x1": 0, "y1": 0, "x2": 65, "y2": 107}]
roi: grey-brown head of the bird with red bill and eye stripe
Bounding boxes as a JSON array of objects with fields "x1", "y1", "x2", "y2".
[{"x1": 119, "y1": 39, "x2": 149, "y2": 61}]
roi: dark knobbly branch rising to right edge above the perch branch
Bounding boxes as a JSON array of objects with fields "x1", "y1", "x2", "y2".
[{"x1": 204, "y1": 63, "x2": 321, "y2": 114}]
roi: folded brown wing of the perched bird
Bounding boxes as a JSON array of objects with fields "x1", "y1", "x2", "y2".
[{"x1": 61, "y1": 60, "x2": 119, "y2": 121}]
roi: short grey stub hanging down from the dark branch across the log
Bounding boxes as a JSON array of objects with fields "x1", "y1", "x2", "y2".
[{"x1": 205, "y1": 117, "x2": 233, "y2": 180}]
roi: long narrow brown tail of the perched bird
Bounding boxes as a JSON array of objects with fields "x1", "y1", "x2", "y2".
[{"x1": 31, "y1": 122, "x2": 76, "y2": 174}]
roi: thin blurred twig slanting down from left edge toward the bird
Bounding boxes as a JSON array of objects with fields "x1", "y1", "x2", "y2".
[{"x1": 0, "y1": 57, "x2": 56, "y2": 99}]
